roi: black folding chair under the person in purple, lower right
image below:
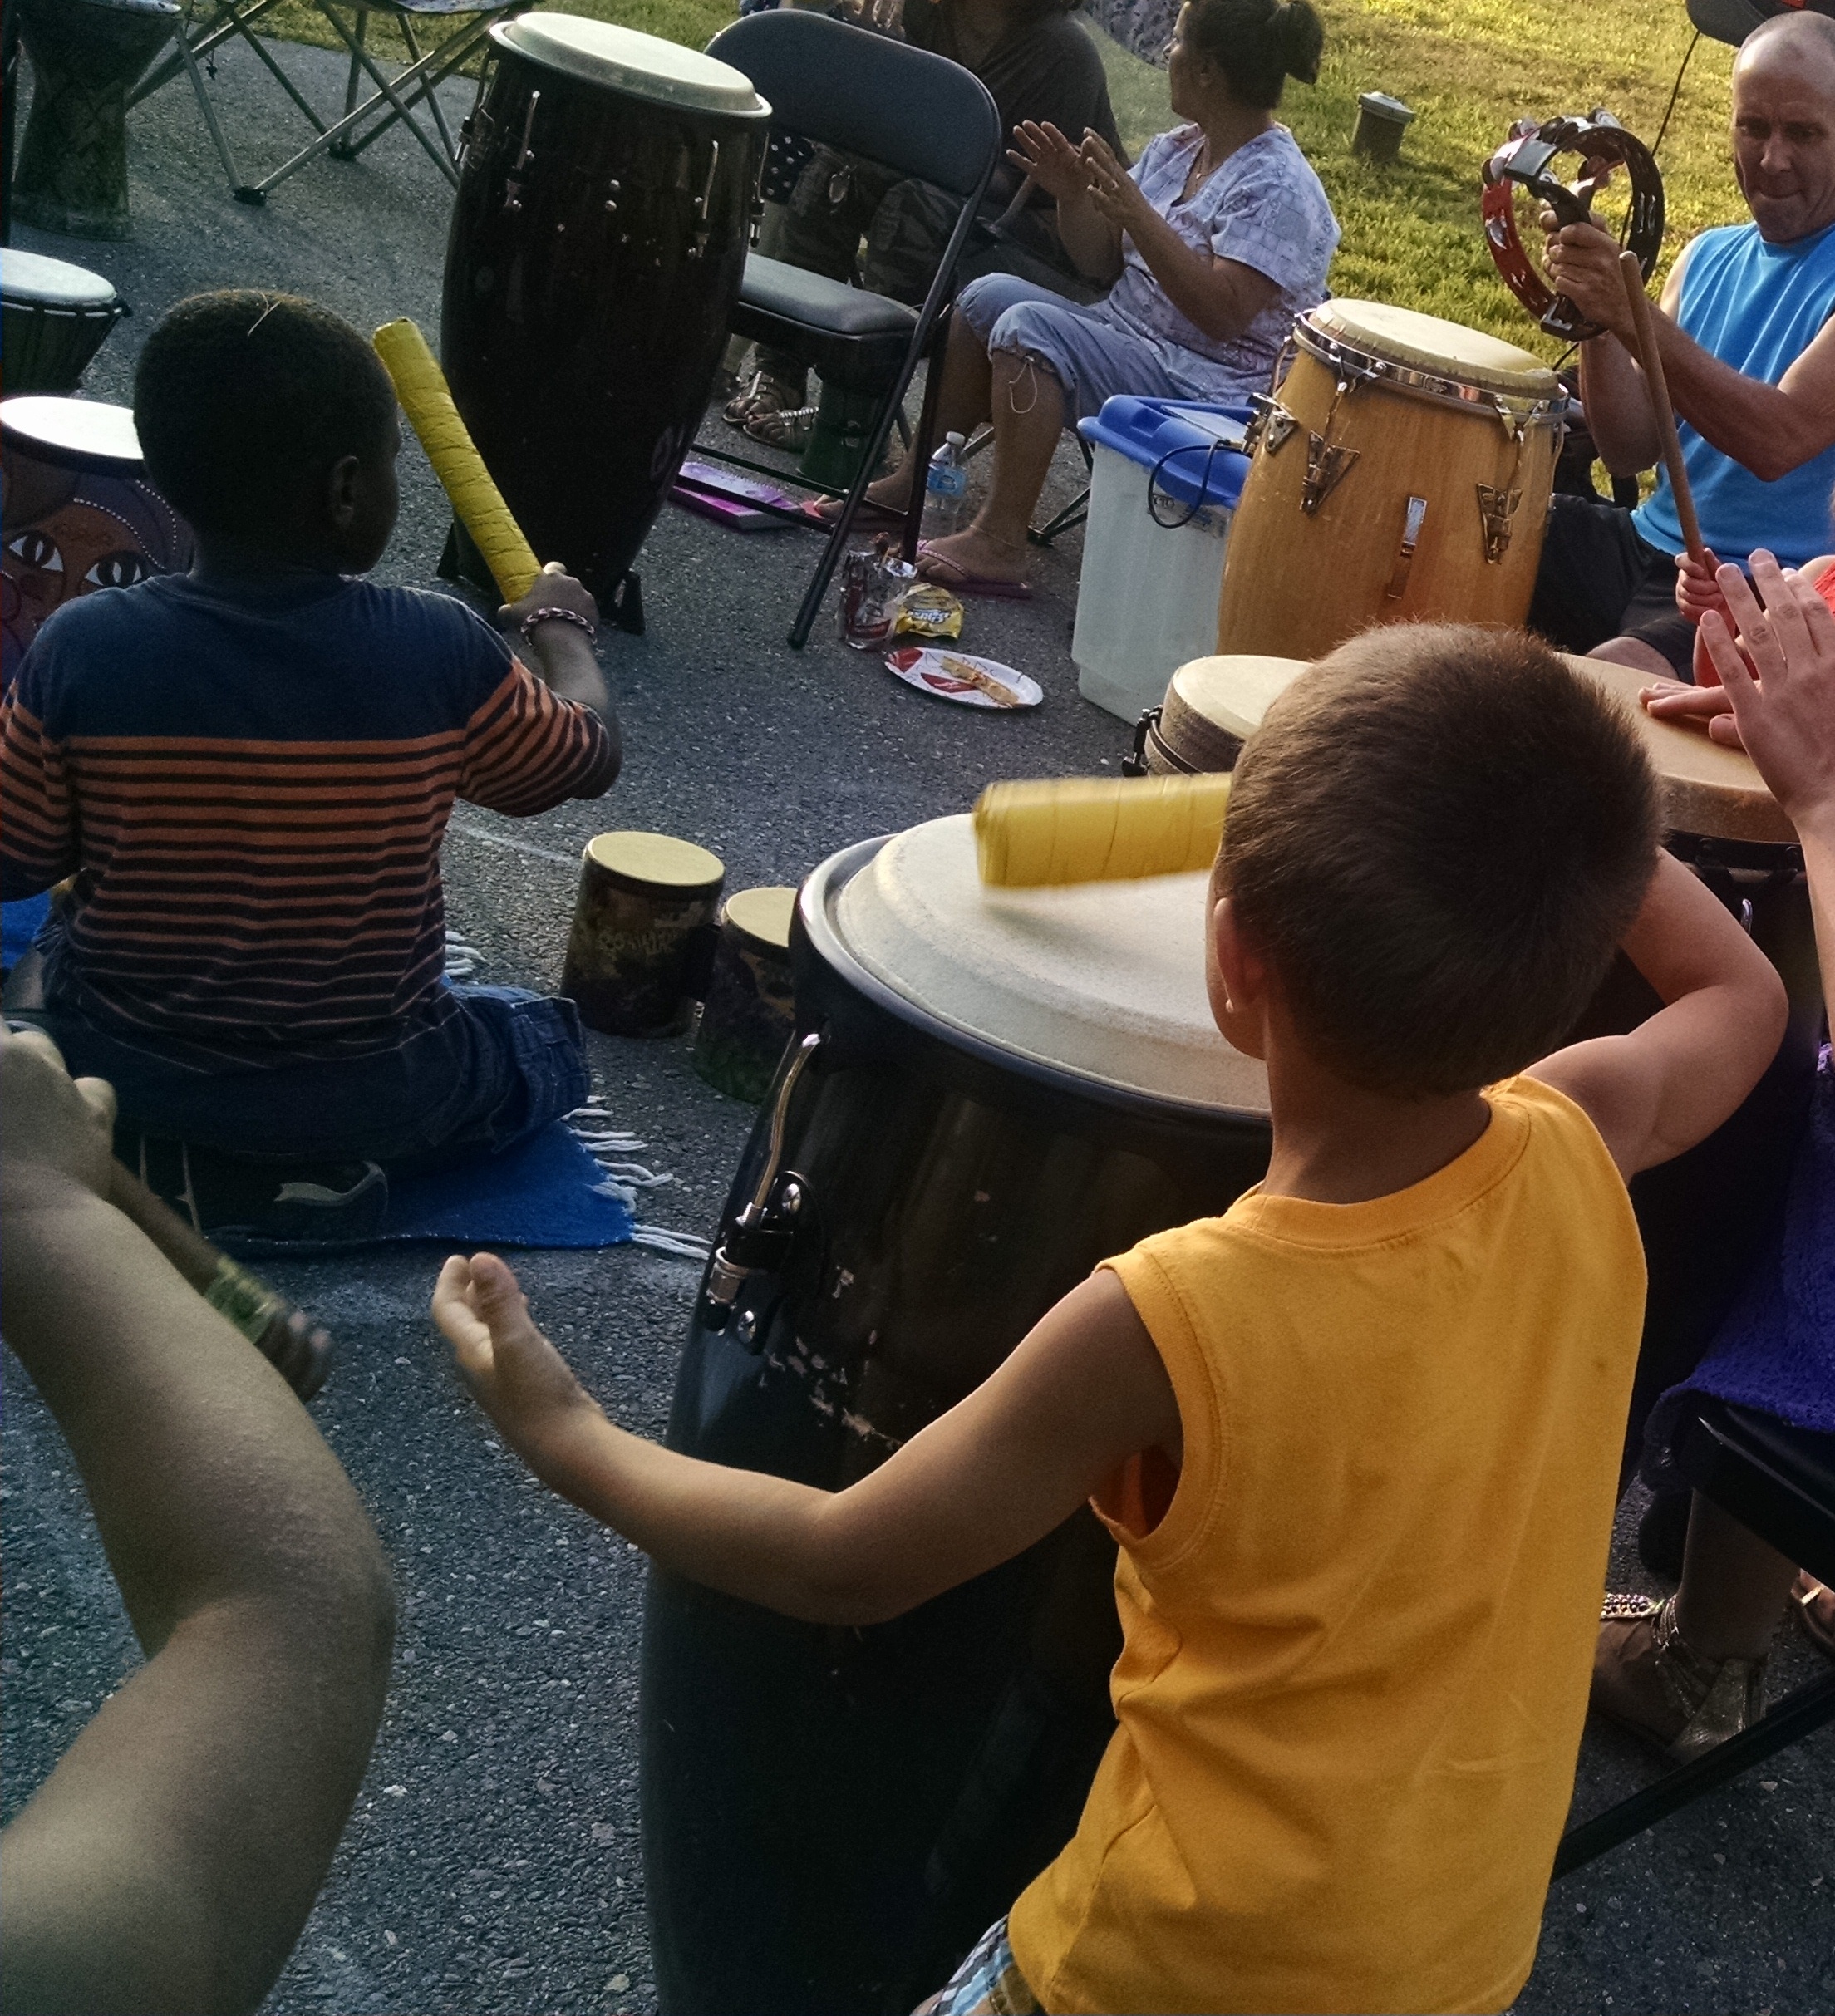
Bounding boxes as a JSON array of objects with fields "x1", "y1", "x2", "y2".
[{"x1": 1555, "y1": 1395, "x2": 1835, "y2": 1879}]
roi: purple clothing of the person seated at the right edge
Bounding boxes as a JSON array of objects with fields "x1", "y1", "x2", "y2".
[{"x1": 1646, "y1": 1046, "x2": 1835, "y2": 1468}]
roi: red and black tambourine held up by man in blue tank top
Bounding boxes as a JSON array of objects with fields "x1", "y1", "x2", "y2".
[{"x1": 1482, "y1": 111, "x2": 1664, "y2": 342}]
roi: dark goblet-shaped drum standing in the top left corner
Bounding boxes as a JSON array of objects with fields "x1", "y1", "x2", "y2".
[{"x1": 12, "y1": 0, "x2": 181, "y2": 238}]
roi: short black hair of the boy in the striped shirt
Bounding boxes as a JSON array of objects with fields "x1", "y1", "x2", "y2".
[{"x1": 133, "y1": 288, "x2": 396, "y2": 538}]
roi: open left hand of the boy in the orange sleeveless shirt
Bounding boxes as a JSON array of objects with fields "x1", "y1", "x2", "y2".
[{"x1": 434, "y1": 1254, "x2": 605, "y2": 1478}]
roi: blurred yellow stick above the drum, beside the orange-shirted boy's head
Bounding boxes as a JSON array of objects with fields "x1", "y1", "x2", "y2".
[{"x1": 974, "y1": 774, "x2": 1230, "y2": 889}]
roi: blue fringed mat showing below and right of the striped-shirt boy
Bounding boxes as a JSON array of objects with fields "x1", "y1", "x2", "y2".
[{"x1": 212, "y1": 1121, "x2": 635, "y2": 1260}]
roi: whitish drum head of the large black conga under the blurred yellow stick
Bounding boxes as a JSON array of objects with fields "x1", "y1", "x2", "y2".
[{"x1": 835, "y1": 817, "x2": 1268, "y2": 1115}]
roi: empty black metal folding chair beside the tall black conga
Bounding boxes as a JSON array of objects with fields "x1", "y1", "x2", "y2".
[{"x1": 698, "y1": 8, "x2": 1000, "y2": 649}]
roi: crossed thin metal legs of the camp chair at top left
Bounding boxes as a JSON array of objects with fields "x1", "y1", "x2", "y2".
[{"x1": 127, "y1": 0, "x2": 534, "y2": 204}]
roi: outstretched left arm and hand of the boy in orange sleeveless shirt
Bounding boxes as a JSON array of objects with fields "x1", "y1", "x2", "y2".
[{"x1": 434, "y1": 1254, "x2": 1179, "y2": 1625}]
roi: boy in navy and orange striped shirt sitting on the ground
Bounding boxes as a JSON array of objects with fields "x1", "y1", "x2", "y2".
[{"x1": 0, "y1": 293, "x2": 619, "y2": 1163}]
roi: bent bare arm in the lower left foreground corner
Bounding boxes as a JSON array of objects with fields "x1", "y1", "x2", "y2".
[{"x1": 0, "y1": 1036, "x2": 393, "y2": 2012}]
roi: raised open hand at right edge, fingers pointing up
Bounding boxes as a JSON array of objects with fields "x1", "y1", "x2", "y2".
[{"x1": 1702, "y1": 553, "x2": 1835, "y2": 837}]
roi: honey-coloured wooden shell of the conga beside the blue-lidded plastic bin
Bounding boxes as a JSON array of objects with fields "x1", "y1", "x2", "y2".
[{"x1": 1218, "y1": 347, "x2": 1561, "y2": 659}]
